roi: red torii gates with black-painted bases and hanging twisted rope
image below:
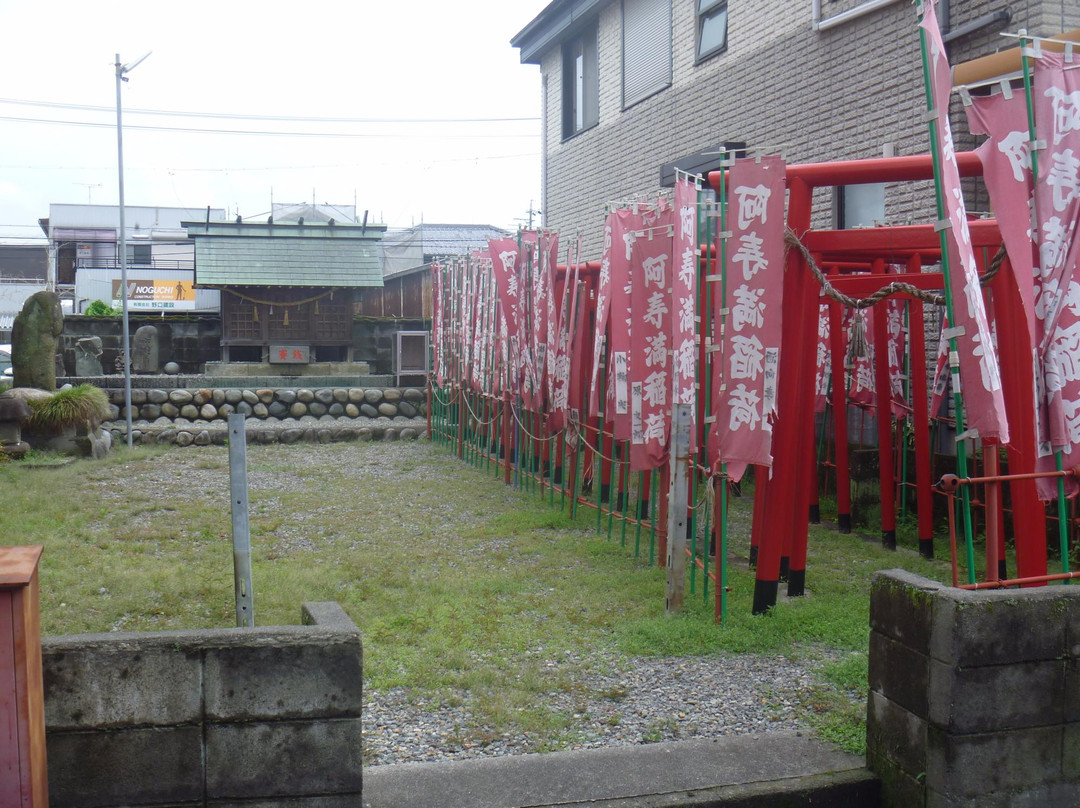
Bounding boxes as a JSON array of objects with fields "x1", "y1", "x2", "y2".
[{"x1": 708, "y1": 152, "x2": 1047, "y2": 614}]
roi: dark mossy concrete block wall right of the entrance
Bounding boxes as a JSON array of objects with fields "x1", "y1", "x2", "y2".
[{"x1": 866, "y1": 570, "x2": 1080, "y2": 808}]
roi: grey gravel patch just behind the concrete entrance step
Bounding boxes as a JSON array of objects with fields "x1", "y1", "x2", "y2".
[{"x1": 362, "y1": 655, "x2": 811, "y2": 766}]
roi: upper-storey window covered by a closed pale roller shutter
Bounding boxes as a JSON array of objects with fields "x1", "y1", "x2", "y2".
[{"x1": 622, "y1": 0, "x2": 672, "y2": 108}]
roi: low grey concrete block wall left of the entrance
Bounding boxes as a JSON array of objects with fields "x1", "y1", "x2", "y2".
[{"x1": 42, "y1": 603, "x2": 363, "y2": 808}]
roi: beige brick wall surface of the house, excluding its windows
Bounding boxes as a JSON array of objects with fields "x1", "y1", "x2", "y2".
[{"x1": 531, "y1": 0, "x2": 1080, "y2": 258}]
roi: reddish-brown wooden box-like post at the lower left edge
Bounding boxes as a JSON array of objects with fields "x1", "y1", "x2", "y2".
[{"x1": 0, "y1": 547, "x2": 49, "y2": 808}]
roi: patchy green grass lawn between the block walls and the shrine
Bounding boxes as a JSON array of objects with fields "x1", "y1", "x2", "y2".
[{"x1": 0, "y1": 443, "x2": 948, "y2": 752}]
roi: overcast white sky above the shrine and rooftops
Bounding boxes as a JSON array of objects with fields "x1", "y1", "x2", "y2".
[{"x1": 0, "y1": 0, "x2": 549, "y2": 242}]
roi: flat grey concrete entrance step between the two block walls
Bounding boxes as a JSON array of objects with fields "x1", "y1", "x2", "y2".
[{"x1": 363, "y1": 731, "x2": 879, "y2": 808}]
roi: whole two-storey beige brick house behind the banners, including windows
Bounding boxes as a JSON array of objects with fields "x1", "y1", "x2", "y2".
[{"x1": 511, "y1": 0, "x2": 1080, "y2": 257}]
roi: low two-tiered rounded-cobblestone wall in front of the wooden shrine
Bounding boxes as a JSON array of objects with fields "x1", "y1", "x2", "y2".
[{"x1": 104, "y1": 388, "x2": 428, "y2": 446}]
